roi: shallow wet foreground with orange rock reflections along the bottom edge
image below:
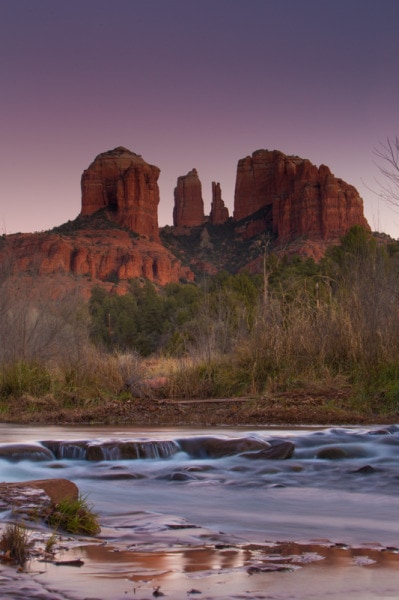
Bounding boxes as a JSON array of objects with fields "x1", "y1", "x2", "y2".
[{"x1": 2, "y1": 533, "x2": 399, "y2": 600}]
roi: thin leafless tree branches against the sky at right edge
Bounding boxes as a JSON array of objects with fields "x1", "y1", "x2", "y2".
[{"x1": 374, "y1": 136, "x2": 399, "y2": 208}]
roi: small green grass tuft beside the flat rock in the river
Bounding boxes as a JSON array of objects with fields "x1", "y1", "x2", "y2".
[{"x1": 48, "y1": 496, "x2": 100, "y2": 535}]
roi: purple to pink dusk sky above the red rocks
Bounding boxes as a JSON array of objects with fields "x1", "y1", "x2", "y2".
[{"x1": 0, "y1": 0, "x2": 399, "y2": 238}]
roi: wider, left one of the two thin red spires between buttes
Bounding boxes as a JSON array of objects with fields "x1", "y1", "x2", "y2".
[{"x1": 173, "y1": 169, "x2": 205, "y2": 227}]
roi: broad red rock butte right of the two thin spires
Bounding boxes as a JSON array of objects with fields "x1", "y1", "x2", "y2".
[{"x1": 234, "y1": 150, "x2": 369, "y2": 242}]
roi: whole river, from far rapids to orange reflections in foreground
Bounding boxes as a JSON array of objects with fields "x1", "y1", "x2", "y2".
[{"x1": 0, "y1": 425, "x2": 399, "y2": 600}]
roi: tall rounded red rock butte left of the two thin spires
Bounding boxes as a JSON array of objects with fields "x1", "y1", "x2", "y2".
[{"x1": 80, "y1": 146, "x2": 160, "y2": 239}]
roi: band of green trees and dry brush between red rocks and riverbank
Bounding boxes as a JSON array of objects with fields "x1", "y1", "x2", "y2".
[{"x1": 0, "y1": 227, "x2": 399, "y2": 418}]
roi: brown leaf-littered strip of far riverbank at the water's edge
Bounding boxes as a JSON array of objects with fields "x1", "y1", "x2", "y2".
[{"x1": 0, "y1": 386, "x2": 398, "y2": 427}]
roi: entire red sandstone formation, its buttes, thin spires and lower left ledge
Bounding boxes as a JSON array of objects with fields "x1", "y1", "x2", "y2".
[{"x1": 0, "y1": 147, "x2": 370, "y2": 297}]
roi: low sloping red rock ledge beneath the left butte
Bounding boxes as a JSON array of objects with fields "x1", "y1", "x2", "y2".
[{"x1": 0, "y1": 227, "x2": 194, "y2": 285}]
